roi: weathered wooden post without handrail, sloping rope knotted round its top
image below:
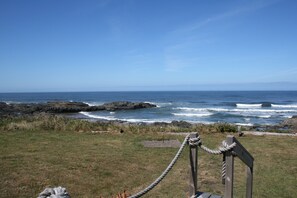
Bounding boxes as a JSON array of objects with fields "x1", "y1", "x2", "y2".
[{"x1": 189, "y1": 133, "x2": 198, "y2": 197}]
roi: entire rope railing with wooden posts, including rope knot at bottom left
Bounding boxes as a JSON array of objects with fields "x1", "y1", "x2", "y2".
[{"x1": 38, "y1": 133, "x2": 254, "y2": 198}]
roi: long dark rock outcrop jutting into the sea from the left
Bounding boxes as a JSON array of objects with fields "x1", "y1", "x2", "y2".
[{"x1": 0, "y1": 101, "x2": 156, "y2": 116}]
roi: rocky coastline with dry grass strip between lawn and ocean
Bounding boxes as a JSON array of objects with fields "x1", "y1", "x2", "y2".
[{"x1": 0, "y1": 101, "x2": 297, "y2": 134}]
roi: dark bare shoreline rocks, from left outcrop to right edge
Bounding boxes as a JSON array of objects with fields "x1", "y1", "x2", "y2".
[{"x1": 0, "y1": 101, "x2": 297, "y2": 133}]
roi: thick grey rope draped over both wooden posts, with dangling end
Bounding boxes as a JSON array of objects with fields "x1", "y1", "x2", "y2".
[{"x1": 129, "y1": 134, "x2": 236, "y2": 198}]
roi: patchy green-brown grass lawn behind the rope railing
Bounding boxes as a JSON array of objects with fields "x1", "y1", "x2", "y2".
[{"x1": 0, "y1": 131, "x2": 297, "y2": 198}]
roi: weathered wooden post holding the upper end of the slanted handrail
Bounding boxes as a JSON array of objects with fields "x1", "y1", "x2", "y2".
[{"x1": 224, "y1": 136, "x2": 234, "y2": 198}]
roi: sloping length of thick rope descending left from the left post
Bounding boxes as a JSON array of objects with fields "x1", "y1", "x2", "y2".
[{"x1": 129, "y1": 135, "x2": 190, "y2": 198}]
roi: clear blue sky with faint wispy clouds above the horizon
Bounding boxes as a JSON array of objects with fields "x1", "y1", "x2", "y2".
[{"x1": 0, "y1": 0, "x2": 297, "y2": 92}]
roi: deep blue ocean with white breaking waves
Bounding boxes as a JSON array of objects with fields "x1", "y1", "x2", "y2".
[{"x1": 0, "y1": 91, "x2": 297, "y2": 126}]
